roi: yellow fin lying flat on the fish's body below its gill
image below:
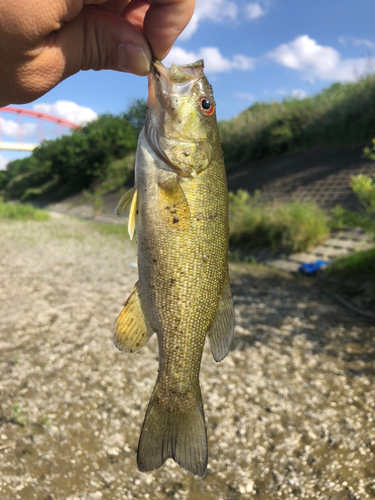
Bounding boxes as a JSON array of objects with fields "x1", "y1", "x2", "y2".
[{"x1": 159, "y1": 174, "x2": 191, "y2": 230}]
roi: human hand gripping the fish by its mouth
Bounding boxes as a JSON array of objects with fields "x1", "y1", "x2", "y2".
[{"x1": 0, "y1": 0, "x2": 195, "y2": 107}]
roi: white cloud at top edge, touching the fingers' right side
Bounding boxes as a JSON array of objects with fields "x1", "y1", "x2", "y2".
[{"x1": 180, "y1": 0, "x2": 238, "y2": 40}]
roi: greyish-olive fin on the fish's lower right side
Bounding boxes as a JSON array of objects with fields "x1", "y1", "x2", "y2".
[{"x1": 208, "y1": 274, "x2": 234, "y2": 362}]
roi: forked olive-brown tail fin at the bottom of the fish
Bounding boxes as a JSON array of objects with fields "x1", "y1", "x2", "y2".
[{"x1": 137, "y1": 383, "x2": 207, "y2": 477}]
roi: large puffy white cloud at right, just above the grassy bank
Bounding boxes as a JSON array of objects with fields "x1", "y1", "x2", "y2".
[{"x1": 268, "y1": 35, "x2": 375, "y2": 82}]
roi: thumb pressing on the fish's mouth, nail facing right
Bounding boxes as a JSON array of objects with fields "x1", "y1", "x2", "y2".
[{"x1": 55, "y1": 7, "x2": 152, "y2": 79}]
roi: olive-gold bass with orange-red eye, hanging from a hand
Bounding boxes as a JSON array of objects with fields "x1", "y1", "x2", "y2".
[{"x1": 114, "y1": 60, "x2": 234, "y2": 476}]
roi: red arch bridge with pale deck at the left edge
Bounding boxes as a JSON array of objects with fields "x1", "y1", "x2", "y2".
[{"x1": 0, "y1": 106, "x2": 80, "y2": 151}]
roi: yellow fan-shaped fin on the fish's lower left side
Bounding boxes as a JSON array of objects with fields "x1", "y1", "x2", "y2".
[{"x1": 113, "y1": 283, "x2": 154, "y2": 353}]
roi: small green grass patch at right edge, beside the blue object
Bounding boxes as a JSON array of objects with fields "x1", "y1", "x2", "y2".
[{"x1": 324, "y1": 248, "x2": 375, "y2": 279}]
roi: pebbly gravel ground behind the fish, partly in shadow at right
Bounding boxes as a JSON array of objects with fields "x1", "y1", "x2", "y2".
[{"x1": 0, "y1": 217, "x2": 375, "y2": 500}]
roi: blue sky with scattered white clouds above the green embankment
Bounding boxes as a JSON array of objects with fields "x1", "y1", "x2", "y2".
[{"x1": 0, "y1": 0, "x2": 375, "y2": 168}]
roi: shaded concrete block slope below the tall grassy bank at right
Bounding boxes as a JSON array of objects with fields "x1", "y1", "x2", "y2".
[{"x1": 227, "y1": 146, "x2": 375, "y2": 210}]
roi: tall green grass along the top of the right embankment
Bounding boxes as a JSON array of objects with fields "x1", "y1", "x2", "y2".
[{"x1": 219, "y1": 75, "x2": 375, "y2": 163}]
